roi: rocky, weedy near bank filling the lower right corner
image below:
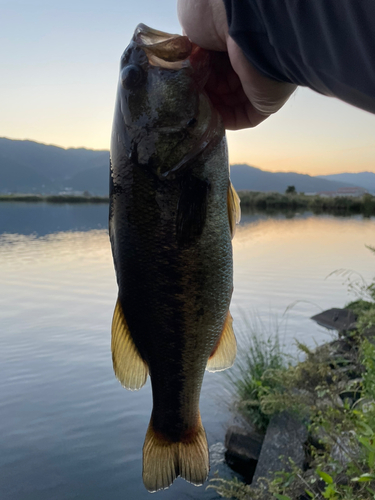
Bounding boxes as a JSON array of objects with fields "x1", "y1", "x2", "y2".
[{"x1": 211, "y1": 254, "x2": 375, "y2": 500}]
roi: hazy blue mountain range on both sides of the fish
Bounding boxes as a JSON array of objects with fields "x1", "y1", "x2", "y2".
[{"x1": 0, "y1": 138, "x2": 375, "y2": 196}]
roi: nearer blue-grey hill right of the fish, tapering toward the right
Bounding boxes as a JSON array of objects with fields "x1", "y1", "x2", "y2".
[{"x1": 230, "y1": 165, "x2": 368, "y2": 193}]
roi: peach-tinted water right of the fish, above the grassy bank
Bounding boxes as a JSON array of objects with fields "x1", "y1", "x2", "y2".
[{"x1": 233, "y1": 214, "x2": 375, "y2": 348}]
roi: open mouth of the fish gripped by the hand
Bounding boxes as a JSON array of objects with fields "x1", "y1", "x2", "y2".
[{"x1": 133, "y1": 24, "x2": 197, "y2": 69}]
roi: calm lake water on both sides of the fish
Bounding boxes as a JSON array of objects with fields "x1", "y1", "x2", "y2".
[{"x1": 0, "y1": 203, "x2": 375, "y2": 500}]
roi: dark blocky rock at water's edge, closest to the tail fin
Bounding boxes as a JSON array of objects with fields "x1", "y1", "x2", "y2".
[{"x1": 225, "y1": 425, "x2": 264, "y2": 483}]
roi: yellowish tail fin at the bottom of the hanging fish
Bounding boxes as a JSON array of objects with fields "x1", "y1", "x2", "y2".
[{"x1": 143, "y1": 415, "x2": 210, "y2": 492}]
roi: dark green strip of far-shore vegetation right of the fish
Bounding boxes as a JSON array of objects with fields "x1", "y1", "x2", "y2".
[{"x1": 238, "y1": 190, "x2": 375, "y2": 216}]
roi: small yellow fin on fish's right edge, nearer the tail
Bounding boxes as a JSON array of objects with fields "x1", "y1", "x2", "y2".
[{"x1": 206, "y1": 311, "x2": 237, "y2": 372}]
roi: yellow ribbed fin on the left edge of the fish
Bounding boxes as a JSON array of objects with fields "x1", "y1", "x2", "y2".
[{"x1": 111, "y1": 299, "x2": 148, "y2": 391}]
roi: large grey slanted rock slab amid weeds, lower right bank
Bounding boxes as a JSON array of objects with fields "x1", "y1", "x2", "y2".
[{"x1": 252, "y1": 411, "x2": 308, "y2": 485}]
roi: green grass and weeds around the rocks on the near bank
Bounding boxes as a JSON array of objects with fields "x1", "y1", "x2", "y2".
[{"x1": 210, "y1": 248, "x2": 375, "y2": 500}]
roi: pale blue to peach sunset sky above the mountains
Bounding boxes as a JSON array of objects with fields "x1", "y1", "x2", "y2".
[{"x1": 0, "y1": 0, "x2": 375, "y2": 175}]
